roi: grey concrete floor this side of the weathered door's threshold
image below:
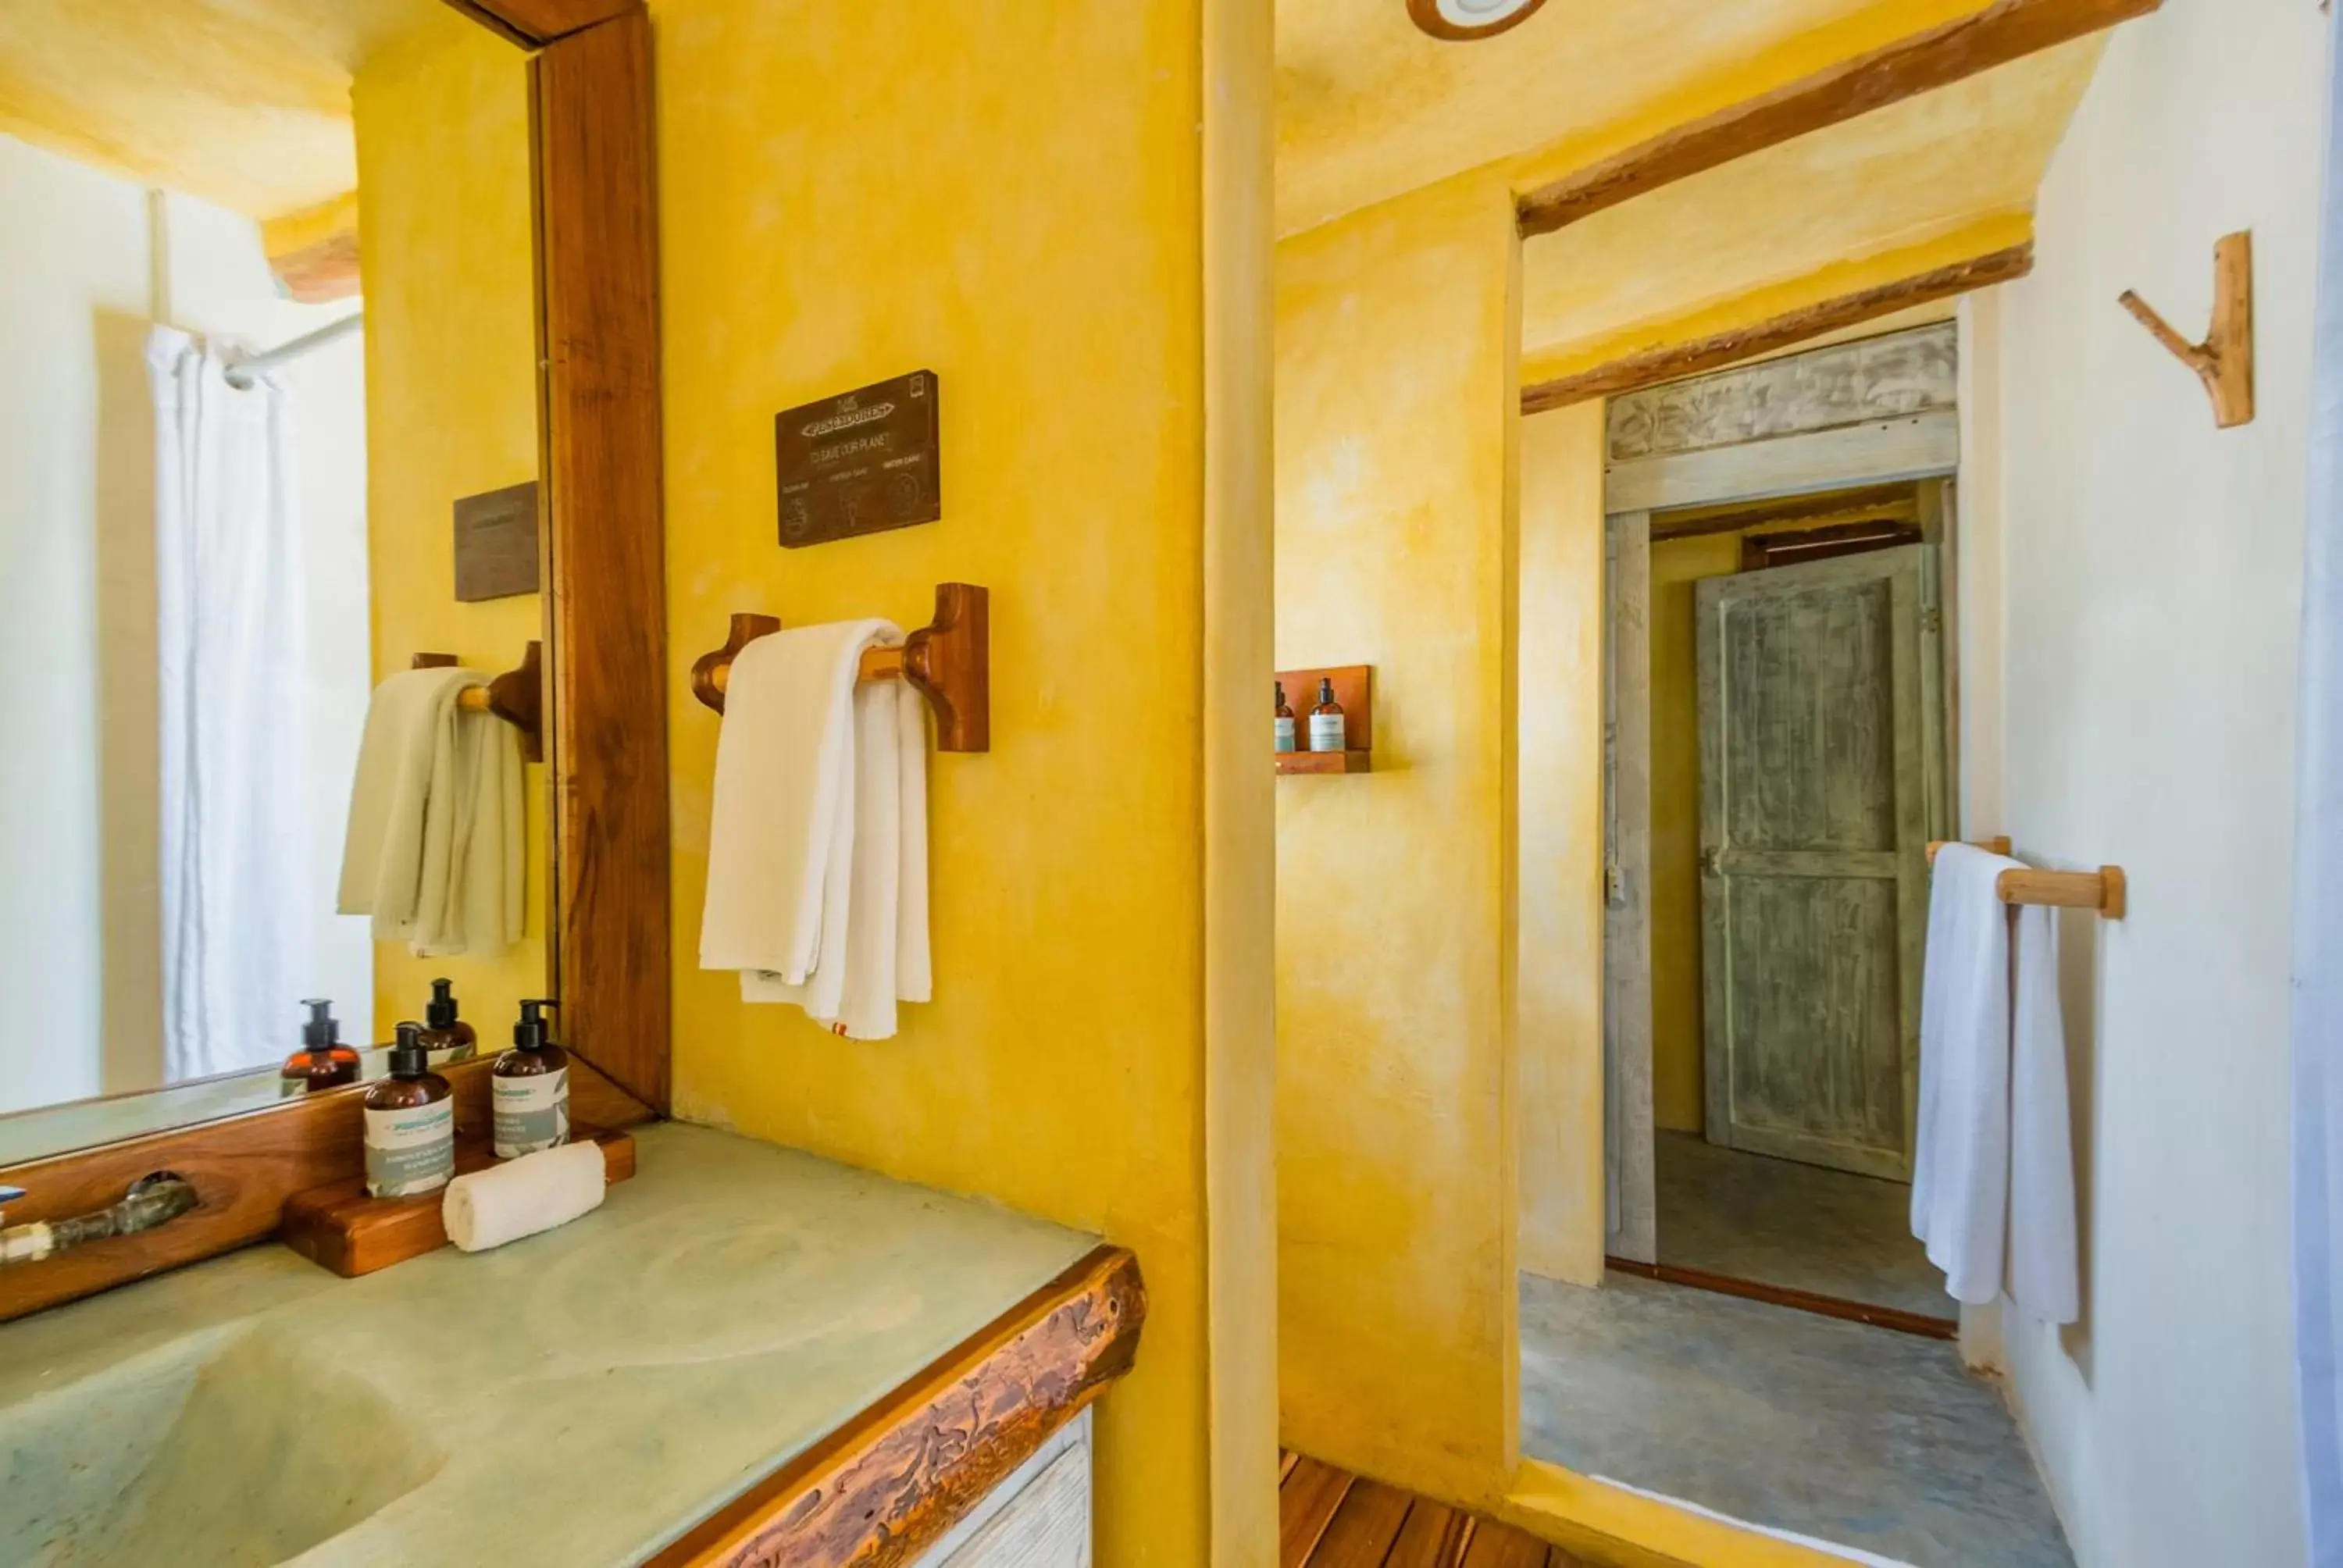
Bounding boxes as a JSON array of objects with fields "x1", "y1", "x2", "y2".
[{"x1": 1521, "y1": 1273, "x2": 2074, "y2": 1568}]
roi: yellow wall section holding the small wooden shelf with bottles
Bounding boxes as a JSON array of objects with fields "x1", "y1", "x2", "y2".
[{"x1": 1263, "y1": 165, "x2": 1518, "y2": 1495}]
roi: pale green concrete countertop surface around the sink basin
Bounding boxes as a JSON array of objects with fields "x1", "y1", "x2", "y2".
[{"x1": 0, "y1": 1123, "x2": 1097, "y2": 1568}]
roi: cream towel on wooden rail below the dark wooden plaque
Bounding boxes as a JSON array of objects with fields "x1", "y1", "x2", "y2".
[{"x1": 701, "y1": 621, "x2": 933, "y2": 1041}]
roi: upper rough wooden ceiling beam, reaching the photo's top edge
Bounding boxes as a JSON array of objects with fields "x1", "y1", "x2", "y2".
[{"x1": 1518, "y1": 0, "x2": 2163, "y2": 234}]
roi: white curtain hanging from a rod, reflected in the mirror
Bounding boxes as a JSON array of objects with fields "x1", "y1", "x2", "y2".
[{"x1": 148, "y1": 326, "x2": 316, "y2": 1081}]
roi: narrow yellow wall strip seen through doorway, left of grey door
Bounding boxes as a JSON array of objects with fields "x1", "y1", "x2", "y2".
[{"x1": 1652, "y1": 532, "x2": 1741, "y2": 1132}]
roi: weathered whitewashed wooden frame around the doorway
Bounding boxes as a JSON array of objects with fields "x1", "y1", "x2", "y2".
[{"x1": 1603, "y1": 424, "x2": 1959, "y2": 1263}]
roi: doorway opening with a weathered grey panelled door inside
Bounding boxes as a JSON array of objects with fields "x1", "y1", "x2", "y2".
[{"x1": 1610, "y1": 469, "x2": 1954, "y2": 1338}]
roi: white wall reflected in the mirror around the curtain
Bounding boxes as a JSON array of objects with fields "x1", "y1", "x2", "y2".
[{"x1": 0, "y1": 138, "x2": 373, "y2": 1111}]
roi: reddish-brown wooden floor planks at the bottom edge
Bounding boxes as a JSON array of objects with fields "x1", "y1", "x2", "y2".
[{"x1": 1277, "y1": 1453, "x2": 1586, "y2": 1568}]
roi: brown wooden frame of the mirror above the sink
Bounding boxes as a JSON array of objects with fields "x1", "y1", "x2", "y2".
[{"x1": 0, "y1": 0, "x2": 670, "y2": 1320}]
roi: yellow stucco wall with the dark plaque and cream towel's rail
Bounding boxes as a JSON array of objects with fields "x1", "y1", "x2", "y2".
[{"x1": 651, "y1": 0, "x2": 1275, "y2": 1568}]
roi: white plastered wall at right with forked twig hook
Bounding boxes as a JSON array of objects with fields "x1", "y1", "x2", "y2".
[{"x1": 1963, "y1": 0, "x2": 2327, "y2": 1568}]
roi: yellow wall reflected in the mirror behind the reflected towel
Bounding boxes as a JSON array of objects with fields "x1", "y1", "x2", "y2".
[{"x1": 351, "y1": 28, "x2": 548, "y2": 1048}]
